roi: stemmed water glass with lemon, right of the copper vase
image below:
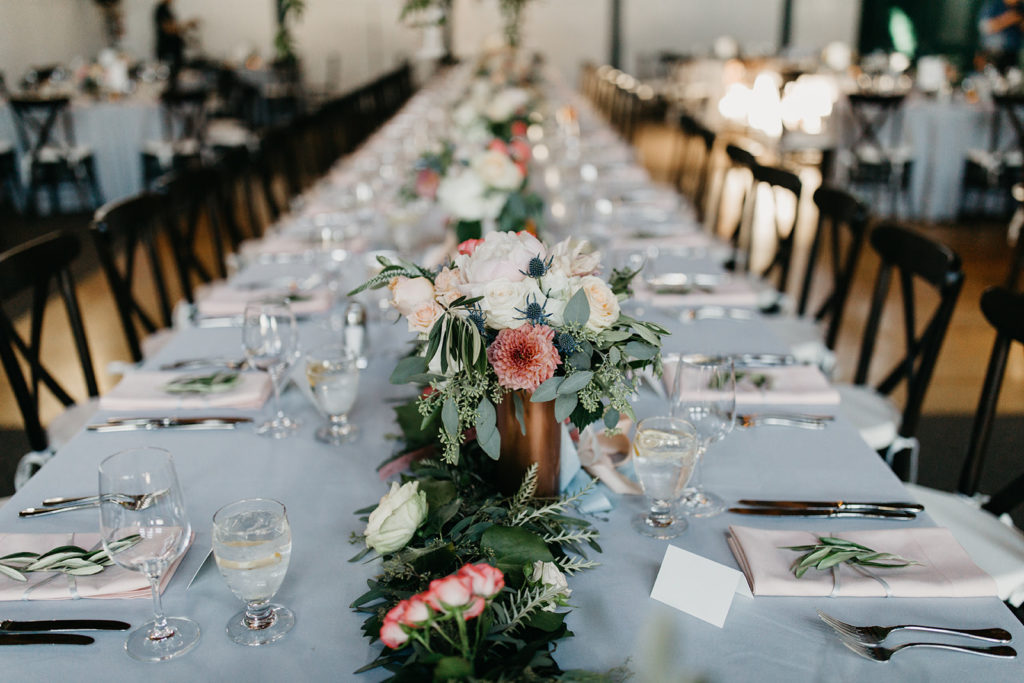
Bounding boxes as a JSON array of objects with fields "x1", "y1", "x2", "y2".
[{"x1": 633, "y1": 417, "x2": 697, "y2": 539}]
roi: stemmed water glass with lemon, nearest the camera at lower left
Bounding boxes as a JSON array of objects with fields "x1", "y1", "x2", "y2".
[{"x1": 213, "y1": 498, "x2": 295, "y2": 646}]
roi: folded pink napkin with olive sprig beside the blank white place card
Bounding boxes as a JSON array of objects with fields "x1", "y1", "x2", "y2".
[{"x1": 728, "y1": 526, "x2": 997, "y2": 598}]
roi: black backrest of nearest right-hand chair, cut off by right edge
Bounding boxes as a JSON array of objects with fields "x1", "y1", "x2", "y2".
[{"x1": 957, "y1": 287, "x2": 1024, "y2": 515}]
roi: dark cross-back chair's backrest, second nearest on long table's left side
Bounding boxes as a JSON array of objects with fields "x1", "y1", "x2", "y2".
[{"x1": 91, "y1": 193, "x2": 181, "y2": 362}]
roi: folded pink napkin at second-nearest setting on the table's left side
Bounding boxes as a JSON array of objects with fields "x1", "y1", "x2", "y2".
[{"x1": 99, "y1": 371, "x2": 270, "y2": 411}]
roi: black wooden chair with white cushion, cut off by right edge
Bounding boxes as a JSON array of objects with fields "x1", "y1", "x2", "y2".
[{"x1": 908, "y1": 288, "x2": 1024, "y2": 607}]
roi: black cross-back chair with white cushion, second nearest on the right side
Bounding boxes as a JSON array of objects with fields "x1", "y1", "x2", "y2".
[{"x1": 838, "y1": 224, "x2": 964, "y2": 481}]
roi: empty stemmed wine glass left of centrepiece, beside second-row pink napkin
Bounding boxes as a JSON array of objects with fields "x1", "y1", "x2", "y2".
[{"x1": 242, "y1": 299, "x2": 299, "y2": 438}]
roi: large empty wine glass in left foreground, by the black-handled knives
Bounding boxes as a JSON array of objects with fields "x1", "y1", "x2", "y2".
[{"x1": 99, "y1": 447, "x2": 200, "y2": 661}]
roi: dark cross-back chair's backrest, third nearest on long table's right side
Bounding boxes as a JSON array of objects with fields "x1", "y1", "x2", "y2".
[{"x1": 797, "y1": 185, "x2": 869, "y2": 349}]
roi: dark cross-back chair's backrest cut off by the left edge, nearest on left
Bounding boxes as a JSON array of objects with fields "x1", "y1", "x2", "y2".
[{"x1": 0, "y1": 232, "x2": 99, "y2": 451}]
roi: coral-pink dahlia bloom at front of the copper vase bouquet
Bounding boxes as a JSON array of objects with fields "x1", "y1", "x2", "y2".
[{"x1": 487, "y1": 324, "x2": 562, "y2": 391}]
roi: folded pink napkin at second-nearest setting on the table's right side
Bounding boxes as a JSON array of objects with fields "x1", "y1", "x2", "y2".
[{"x1": 662, "y1": 358, "x2": 839, "y2": 409}]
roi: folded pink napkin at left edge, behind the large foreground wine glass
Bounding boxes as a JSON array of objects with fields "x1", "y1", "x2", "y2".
[{"x1": 0, "y1": 532, "x2": 195, "y2": 601}]
